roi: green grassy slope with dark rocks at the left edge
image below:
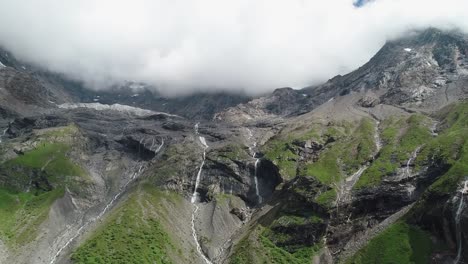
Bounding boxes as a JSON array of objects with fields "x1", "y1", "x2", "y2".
[{"x1": 0, "y1": 125, "x2": 89, "y2": 247}]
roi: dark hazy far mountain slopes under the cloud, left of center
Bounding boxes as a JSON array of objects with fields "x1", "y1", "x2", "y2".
[{"x1": 0, "y1": 49, "x2": 252, "y2": 120}]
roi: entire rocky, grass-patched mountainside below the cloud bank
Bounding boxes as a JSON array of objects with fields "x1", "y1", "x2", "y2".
[{"x1": 0, "y1": 28, "x2": 468, "y2": 264}]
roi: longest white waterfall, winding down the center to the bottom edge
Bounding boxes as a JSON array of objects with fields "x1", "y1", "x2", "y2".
[{"x1": 191, "y1": 123, "x2": 212, "y2": 264}]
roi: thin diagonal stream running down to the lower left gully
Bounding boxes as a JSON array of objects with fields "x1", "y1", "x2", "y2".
[{"x1": 50, "y1": 139, "x2": 164, "y2": 264}]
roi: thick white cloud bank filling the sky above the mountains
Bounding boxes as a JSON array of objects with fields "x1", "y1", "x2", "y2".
[{"x1": 0, "y1": 0, "x2": 468, "y2": 94}]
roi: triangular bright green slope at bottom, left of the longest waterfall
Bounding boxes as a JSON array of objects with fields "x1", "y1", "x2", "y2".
[{"x1": 72, "y1": 185, "x2": 189, "y2": 264}]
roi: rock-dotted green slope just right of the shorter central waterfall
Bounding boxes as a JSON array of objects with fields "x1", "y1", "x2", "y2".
[{"x1": 262, "y1": 118, "x2": 376, "y2": 207}]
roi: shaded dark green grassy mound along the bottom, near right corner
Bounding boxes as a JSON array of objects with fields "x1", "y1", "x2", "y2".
[{"x1": 346, "y1": 222, "x2": 432, "y2": 264}]
